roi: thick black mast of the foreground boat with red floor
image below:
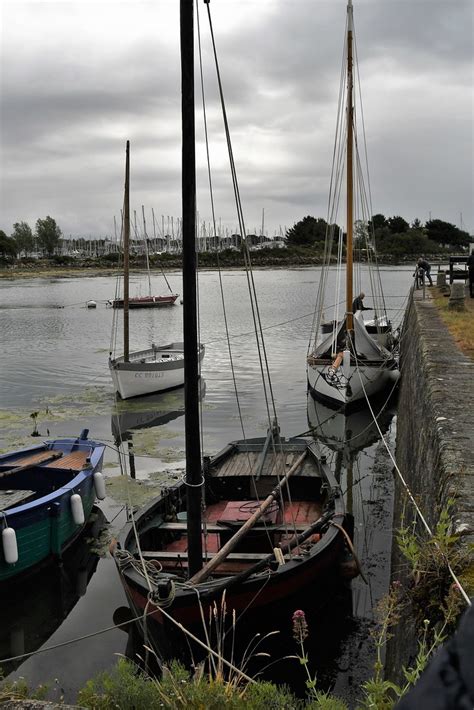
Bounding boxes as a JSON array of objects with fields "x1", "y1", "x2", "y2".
[{"x1": 180, "y1": 0, "x2": 202, "y2": 577}]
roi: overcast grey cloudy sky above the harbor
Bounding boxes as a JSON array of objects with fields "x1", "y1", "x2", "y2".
[{"x1": 0, "y1": 0, "x2": 474, "y2": 242}]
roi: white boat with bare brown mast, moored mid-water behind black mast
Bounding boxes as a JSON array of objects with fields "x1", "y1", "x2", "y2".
[{"x1": 109, "y1": 141, "x2": 204, "y2": 399}]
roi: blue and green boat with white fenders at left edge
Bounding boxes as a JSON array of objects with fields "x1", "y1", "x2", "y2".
[{"x1": 0, "y1": 429, "x2": 105, "y2": 582}]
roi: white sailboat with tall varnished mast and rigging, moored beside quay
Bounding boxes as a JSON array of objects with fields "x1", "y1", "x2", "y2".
[{"x1": 307, "y1": 0, "x2": 399, "y2": 409}]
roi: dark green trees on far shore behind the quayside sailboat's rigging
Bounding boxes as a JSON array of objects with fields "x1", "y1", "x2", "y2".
[{"x1": 286, "y1": 214, "x2": 472, "y2": 256}]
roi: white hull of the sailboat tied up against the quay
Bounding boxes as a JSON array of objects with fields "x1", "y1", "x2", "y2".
[{"x1": 307, "y1": 362, "x2": 399, "y2": 409}]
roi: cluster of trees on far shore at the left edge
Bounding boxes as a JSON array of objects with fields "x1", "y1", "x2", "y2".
[{"x1": 0, "y1": 216, "x2": 63, "y2": 259}]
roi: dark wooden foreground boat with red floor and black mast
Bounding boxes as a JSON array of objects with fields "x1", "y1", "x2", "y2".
[{"x1": 113, "y1": 0, "x2": 356, "y2": 658}]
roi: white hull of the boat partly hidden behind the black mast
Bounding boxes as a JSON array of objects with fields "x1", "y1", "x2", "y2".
[{"x1": 109, "y1": 343, "x2": 204, "y2": 399}]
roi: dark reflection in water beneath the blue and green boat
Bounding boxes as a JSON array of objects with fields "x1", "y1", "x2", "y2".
[{"x1": 0, "y1": 507, "x2": 107, "y2": 676}]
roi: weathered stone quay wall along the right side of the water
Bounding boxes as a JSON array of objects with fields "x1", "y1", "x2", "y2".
[{"x1": 395, "y1": 291, "x2": 474, "y2": 544}]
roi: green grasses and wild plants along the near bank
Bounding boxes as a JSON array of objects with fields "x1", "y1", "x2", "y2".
[{"x1": 0, "y1": 501, "x2": 474, "y2": 710}]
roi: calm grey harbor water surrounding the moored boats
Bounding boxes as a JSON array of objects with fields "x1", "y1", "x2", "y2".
[{"x1": 0, "y1": 267, "x2": 412, "y2": 700}]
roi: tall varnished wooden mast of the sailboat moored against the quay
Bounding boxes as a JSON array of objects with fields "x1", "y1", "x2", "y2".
[{"x1": 346, "y1": 0, "x2": 354, "y2": 333}]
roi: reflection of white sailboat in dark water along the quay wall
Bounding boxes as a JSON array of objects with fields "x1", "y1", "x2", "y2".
[{"x1": 307, "y1": 395, "x2": 396, "y2": 707}]
